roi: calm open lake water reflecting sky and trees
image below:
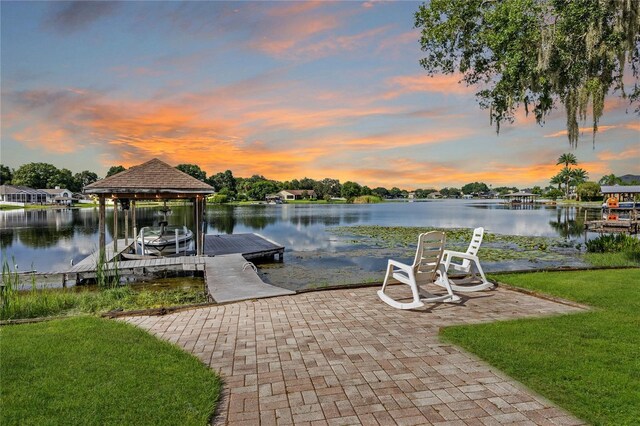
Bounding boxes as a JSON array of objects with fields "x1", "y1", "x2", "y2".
[{"x1": 0, "y1": 200, "x2": 600, "y2": 289}]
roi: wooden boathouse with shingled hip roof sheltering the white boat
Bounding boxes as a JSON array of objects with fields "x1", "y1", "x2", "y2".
[{"x1": 84, "y1": 158, "x2": 215, "y2": 255}]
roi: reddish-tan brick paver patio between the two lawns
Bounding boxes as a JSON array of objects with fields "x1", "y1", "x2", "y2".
[{"x1": 126, "y1": 288, "x2": 581, "y2": 425}]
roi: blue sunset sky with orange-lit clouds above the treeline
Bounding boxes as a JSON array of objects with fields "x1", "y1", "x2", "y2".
[{"x1": 0, "y1": 2, "x2": 640, "y2": 189}]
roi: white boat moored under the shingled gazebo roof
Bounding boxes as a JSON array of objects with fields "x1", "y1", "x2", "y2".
[{"x1": 136, "y1": 223, "x2": 193, "y2": 256}]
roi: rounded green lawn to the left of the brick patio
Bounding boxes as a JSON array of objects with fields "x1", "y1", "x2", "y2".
[{"x1": 0, "y1": 317, "x2": 221, "y2": 425}]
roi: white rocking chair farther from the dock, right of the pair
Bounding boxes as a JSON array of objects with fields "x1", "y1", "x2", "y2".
[{"x1": 436, "y1": 228, "x2": 493, "y2": 293}]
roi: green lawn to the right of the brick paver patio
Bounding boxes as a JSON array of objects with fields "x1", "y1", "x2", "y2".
[{"x1": 441, "y1": 269, "x2": 640, "y2": 425}]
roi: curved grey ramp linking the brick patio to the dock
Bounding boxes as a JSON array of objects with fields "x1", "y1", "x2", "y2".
[{"x1": 204, "y1": 253, "x2": 295, "y2": 303}]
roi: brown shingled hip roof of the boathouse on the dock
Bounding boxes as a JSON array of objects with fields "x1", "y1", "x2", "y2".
[{"x1": 83, "y1": 158, "x2": 215, "y2": 198}]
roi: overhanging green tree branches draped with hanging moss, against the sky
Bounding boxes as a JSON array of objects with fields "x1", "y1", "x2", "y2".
[{"x1": 415, "y1": 0, "x2": 640, "y2": 146}]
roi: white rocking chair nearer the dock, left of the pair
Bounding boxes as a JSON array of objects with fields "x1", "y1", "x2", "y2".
[{"x1": 378, "y1": 231, "x2": 460, "y2": 309}]
